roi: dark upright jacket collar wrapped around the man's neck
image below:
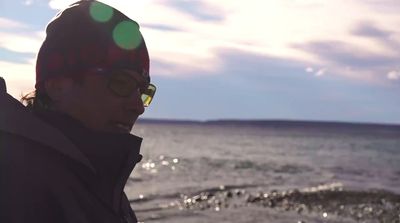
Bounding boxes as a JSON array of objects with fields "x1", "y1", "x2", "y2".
[{"x1": 36, "y1": 111, "x2": 142, "y2": 211}]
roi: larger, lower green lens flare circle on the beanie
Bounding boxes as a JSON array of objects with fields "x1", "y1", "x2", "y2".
[{"x1": 113, "y1": 21, "x2": 142, "y2": 50}]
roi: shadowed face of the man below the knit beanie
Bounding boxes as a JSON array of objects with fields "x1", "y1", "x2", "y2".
[{"x1": 61, "y1": 70, "x2": 148, "y2": 133}]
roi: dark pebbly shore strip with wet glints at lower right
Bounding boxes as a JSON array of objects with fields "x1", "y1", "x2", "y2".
[{"x1": 169, "y1": 184, "x2": 400, "y2": 223}]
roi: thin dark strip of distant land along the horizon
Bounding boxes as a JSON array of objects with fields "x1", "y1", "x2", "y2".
[{"x1": 138, "y1": 118, "x2": 400, "y2": 131}]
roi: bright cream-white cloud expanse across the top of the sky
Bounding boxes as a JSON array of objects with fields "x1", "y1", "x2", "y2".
[{"x1": 20, "y1": 0, "x2": 400, "y2": 82}]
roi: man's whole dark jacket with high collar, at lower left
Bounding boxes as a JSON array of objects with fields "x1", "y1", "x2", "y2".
[{"x1": 0, "y1": 78, "x2": 142, "y2": 223}]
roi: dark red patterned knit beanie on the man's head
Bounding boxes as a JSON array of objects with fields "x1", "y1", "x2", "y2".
[{"x1": 35, "y1": 0, "x2": 150, "y2": 89}]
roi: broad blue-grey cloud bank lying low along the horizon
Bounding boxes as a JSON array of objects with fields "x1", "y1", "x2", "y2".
[{"x1": 146, "y1": 48, "x2": 400, "y2": 123}]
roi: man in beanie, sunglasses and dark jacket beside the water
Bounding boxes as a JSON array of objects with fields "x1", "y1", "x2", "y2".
[{"x1": 0, "y1": 0, "x2": 155, "y2": 223}]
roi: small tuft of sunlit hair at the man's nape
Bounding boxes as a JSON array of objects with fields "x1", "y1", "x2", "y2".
[{"x1": 20, "y1": 89, "x2": 53, "y2": 111}]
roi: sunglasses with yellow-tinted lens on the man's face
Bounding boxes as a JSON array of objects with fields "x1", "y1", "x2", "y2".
[{"x1": 92, "y1": 69, "x2": 157, "y2": 107}]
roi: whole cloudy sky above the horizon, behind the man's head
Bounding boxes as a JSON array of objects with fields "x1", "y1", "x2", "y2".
[{"x1": 0, "y1": 0, "x2": 400, "y2": 124}]
